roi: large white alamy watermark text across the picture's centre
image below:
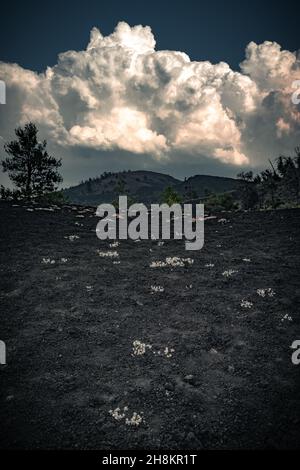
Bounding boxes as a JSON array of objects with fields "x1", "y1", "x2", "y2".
[{"x1": 96, "y1": 196, "x2": 204, "y2": 250}]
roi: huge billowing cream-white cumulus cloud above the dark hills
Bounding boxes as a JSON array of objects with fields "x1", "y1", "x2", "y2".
[{"x1": 0, "y1": 22, "x2": 300, "y2": 183}]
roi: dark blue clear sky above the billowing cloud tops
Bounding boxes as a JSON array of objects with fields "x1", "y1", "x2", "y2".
[{"x1": 0, "y1": 0, "x2": 300, "y2": 71}]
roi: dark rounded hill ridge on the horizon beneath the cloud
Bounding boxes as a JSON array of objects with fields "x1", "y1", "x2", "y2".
[{"x1": 63, "y1": 170, "x2": 238, "y2": 206}]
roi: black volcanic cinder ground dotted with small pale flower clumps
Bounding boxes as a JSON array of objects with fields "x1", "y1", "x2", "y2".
[{"x1": 0, "y1": 203, "x2": 300, "y2": 449}]
